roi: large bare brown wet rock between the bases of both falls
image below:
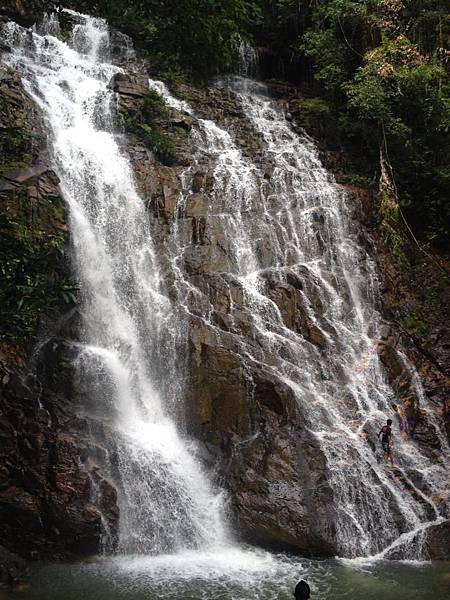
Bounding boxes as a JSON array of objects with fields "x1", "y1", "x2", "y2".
[{"x1": 186, "y1": 321, "x2": 335, "y2": 555}]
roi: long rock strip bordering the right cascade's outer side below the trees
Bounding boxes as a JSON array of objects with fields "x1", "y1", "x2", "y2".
[{"x1": 282, "y1": 82, "x2": 450, "y2": 456}]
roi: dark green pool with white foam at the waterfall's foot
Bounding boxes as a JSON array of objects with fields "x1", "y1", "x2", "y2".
[{"x1": 0, "y1": 549, "x2": 450, "y2": 600}]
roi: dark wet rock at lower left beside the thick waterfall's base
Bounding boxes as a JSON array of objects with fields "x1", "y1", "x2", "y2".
[{"x1": 0, "y1": 339, "x2": 118, "y2": 558}]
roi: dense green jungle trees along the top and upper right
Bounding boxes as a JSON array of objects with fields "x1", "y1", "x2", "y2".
[{"x1": 44, "y1": 0, "x2": 450, "y2": 250}]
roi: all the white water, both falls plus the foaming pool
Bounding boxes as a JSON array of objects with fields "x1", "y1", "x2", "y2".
[{"x1": 3, "y1": 13, "x2": 448, "y2": 599}]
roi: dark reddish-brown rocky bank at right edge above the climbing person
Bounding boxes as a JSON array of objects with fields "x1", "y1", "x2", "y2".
[{"x1": 378, "y1": 243, "x2": 450, "y2": 448}]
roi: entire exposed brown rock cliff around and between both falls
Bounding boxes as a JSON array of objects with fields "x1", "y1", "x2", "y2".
[{"x1": 0, "y1": 5, "x2": 450, "y2": 580}]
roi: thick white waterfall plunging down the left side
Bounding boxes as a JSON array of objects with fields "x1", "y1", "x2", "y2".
[{"x1": 3, "y1": 13, "x2": 226, "y2": 553}]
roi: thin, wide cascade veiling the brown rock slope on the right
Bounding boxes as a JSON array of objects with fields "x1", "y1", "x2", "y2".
[{"x1": 150, "y1": 78, "x2": 448, "y2": 558}]
